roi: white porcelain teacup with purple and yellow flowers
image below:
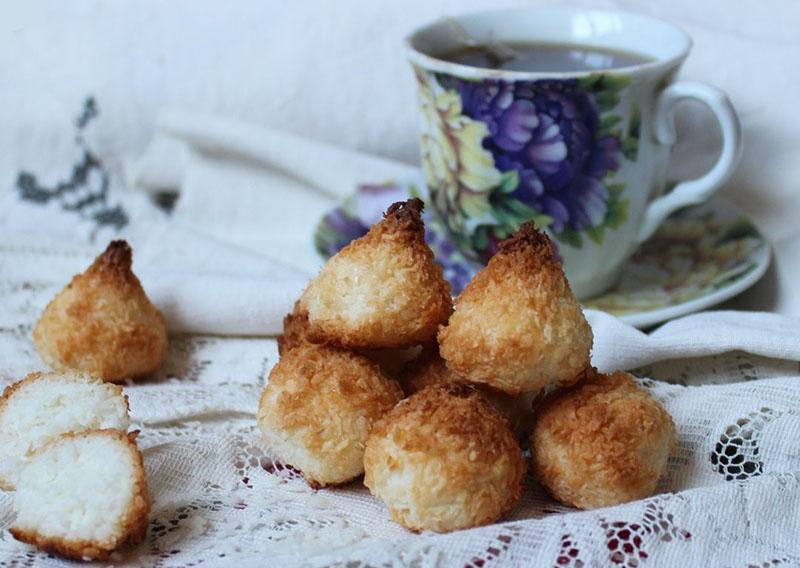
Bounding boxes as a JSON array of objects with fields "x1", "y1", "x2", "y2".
[{"x1": 406, "y1": 8, "x2": 741, "y2": 298}]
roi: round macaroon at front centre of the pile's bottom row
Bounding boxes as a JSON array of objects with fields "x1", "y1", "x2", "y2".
[{"x1": 364, "y1": 384, "x2": 525, "y2": 532}]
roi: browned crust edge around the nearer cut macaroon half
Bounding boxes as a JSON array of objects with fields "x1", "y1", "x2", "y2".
[{"x1": 9, "y1": 429, "x2": 150, "y2": 560}]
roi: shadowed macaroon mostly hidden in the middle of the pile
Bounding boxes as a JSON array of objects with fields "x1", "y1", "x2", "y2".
[{"x1": 400, "y1": 343, "x2": 538, "y2": 436}]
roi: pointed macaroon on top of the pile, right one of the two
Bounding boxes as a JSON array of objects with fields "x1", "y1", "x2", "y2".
[{"x1": 439, "y1": 223, "x2": 592, "y2": 394}]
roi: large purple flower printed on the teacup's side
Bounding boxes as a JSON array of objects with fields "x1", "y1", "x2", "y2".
[{"x1": 440, "y1": 77, "x2": 622, "y2": 233}]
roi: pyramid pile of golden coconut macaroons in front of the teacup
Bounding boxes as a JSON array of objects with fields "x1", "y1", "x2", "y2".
[{"x1": 258, "y1": 199, "x2": 675, "y2": 532}]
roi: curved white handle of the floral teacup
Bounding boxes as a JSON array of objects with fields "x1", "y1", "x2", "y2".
[{"x1": 636, "y1": 81, "x2": 742, "y2": 244}]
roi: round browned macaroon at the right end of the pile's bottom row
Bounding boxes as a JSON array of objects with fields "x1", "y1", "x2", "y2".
[{"x1": 531, "y1": 372, "x2": 676, "y2": 509}]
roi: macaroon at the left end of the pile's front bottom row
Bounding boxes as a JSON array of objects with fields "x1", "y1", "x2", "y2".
[{"x1": 258, "y1": 343, "x2": 403, "y2": 487}]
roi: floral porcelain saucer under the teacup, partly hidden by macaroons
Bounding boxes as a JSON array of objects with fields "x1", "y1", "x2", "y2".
[{"x1": 314, "y1": 179, "x2": 770, "y2": 328}]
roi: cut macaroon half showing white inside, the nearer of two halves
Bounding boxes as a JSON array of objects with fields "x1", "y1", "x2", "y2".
[{"x1": 11, "y1": 430, "x2": 150, "y2": 560}]
